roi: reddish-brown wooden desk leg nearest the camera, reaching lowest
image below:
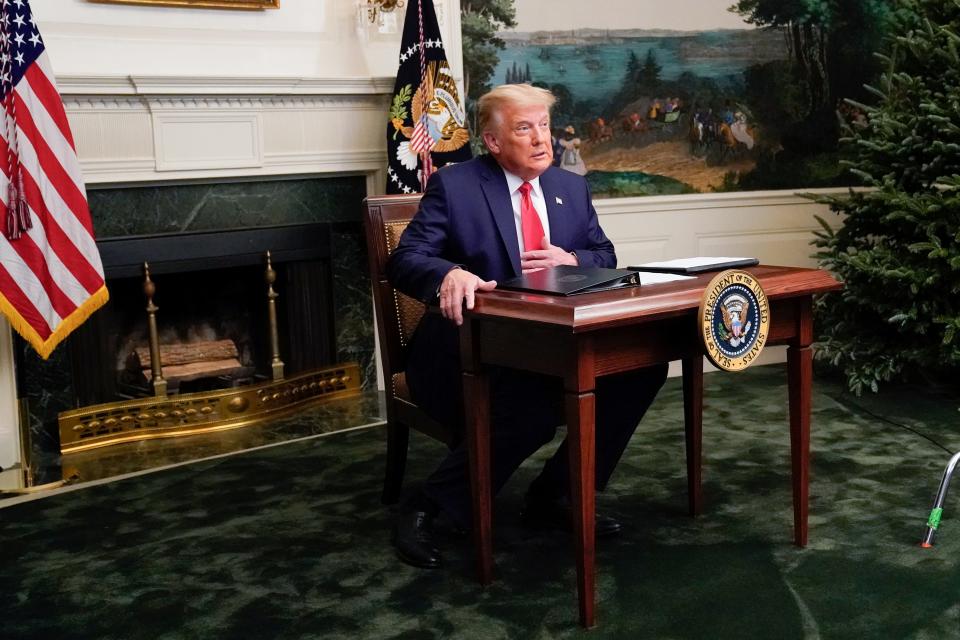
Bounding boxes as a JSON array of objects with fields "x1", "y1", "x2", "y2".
[{"x1": 566, "y1": 391, "x2": 596, "y2": 628}]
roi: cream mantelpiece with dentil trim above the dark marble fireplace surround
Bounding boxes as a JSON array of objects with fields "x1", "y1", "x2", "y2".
[{"x1": 58, "y1": 75, "x2": 393, "y2": 190}]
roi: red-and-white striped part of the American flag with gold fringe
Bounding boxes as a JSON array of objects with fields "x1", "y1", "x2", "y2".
[{"x1": 0, "y1": 53, "x2": 106, "y2": 357}]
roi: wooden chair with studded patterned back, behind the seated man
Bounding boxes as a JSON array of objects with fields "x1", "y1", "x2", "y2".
[{"x1": 363, "y1": 194, "x2": 454, "y2": 504}]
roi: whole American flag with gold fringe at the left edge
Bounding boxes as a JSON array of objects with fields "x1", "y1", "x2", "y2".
[{"x1": 0, "y1": 0, "x2": 108, "y2": 358}]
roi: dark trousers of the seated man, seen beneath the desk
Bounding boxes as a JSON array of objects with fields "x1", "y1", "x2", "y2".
[{"x1": 407, "y1": 318, "x2": 667, "y2": 528}]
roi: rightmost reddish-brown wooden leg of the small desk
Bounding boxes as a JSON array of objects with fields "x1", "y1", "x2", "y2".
[{"x1": 787, "y1": 346, "x2": 813, "y2": 547}]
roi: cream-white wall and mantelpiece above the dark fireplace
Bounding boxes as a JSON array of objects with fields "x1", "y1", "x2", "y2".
[{"x1": 35, "y1": 0, "x2": 462, "y2": 192}]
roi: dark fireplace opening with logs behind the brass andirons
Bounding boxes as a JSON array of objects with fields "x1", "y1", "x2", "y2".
[{"x1": 69, "y1": 223, "x2": 336, "y2": 406}]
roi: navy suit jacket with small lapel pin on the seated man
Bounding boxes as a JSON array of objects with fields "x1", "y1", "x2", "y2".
[{"x1": 387, "y1": 156, "x2": 617, "y2": 304}]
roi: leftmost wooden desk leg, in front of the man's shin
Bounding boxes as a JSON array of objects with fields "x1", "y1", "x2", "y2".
[{"x1": 463, "y1": 372, "x2": 493, "y2": 585}]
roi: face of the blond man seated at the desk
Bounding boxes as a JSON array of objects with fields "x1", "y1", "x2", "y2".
[{"x1": 483, "y1": 104, "x2": 553, "y2": 180}]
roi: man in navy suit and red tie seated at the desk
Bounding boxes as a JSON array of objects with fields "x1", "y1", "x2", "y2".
[{"x1": 387, "y1": 85, "x2": 666, "y2": 568}]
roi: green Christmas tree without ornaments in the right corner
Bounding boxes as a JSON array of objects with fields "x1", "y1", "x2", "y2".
[{"x1": 815, "y1": 0, "x2": 960, "y2": 394}]
